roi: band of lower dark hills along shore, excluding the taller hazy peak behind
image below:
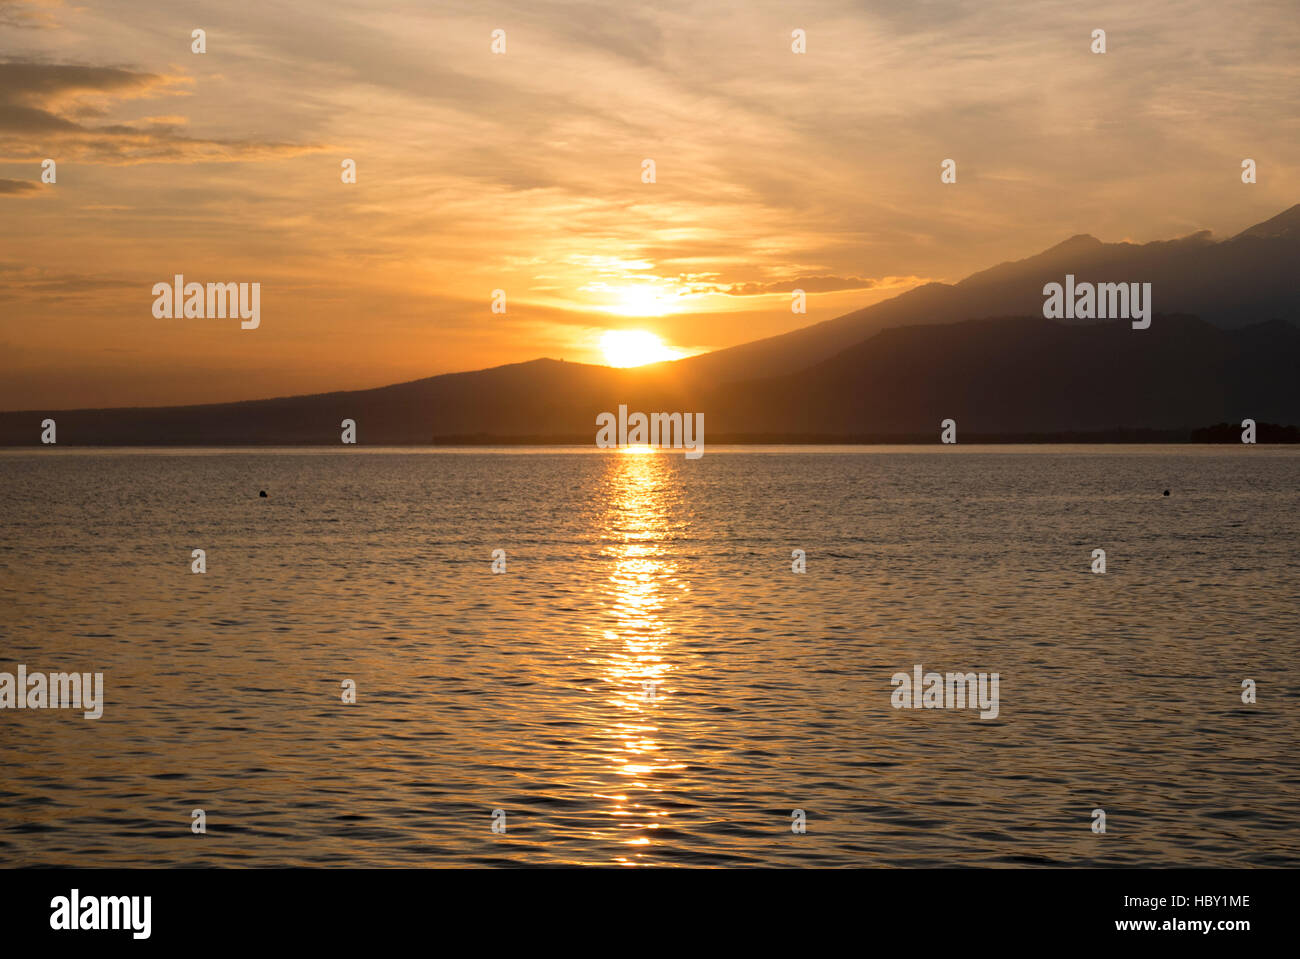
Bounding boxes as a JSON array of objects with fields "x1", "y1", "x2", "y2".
[{"x1": 0, "y1": 313, "x2": 1300, "y2": 446}]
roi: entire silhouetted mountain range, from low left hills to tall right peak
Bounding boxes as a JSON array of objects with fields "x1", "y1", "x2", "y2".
[{"x1": 0, "y1": 205, "x2": 1300, "y2": 446}]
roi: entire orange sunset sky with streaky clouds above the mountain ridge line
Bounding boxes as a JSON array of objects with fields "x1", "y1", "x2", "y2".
[{"x1": 0, "y1": 0, "x2": 1300, "y2": 409}]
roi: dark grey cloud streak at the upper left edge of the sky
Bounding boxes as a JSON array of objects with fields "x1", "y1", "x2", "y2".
[{"x1": 0, "y1": 61, "x2": 321, "y2": 164}]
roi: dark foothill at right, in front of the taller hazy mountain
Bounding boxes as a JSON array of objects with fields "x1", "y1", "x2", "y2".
[{"x1": 702, "y1": 314, "x2": 1300, "y2": 438}]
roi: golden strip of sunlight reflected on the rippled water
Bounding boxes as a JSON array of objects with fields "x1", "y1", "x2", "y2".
[{"x1": 595, "y1": 447, "x2": 683, "y2": 865}]
